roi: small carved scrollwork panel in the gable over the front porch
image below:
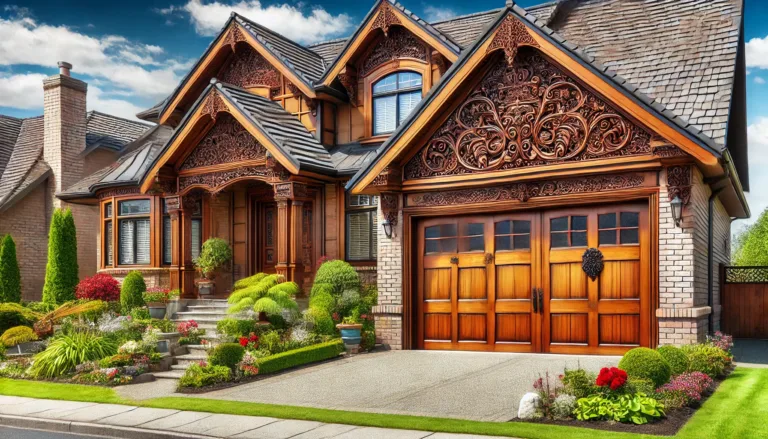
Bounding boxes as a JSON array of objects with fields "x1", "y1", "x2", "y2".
[{"x1": 179, "y1": 113, "x2": 267, "y2": 170}]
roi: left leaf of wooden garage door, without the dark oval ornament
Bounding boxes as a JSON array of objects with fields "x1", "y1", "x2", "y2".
[{"x1": 416, "y1": 214, "x2": 540, "y2": 352}]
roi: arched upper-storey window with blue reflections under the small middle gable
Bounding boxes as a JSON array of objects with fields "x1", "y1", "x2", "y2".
[{"x1": 373, "y1": 72, "x2": 421, "y2": 136}]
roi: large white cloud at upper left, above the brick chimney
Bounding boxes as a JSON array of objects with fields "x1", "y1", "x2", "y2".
[{"x1": 0, "y1": 15, "x2": 190, "y2": 101}]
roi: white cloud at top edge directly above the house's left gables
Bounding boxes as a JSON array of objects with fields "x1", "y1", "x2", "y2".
[{"x1": 177, "y1": 0, "x2": 352, "y2": 43}]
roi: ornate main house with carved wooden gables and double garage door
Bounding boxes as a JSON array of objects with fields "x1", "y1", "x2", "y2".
[{"x1": 60, "y1": 0, "x2": 749, "y2": 354}]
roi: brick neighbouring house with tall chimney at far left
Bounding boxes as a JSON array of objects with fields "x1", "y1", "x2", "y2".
[{"x1": 0, "y1": 63, "x2": 151, "y2": 300}]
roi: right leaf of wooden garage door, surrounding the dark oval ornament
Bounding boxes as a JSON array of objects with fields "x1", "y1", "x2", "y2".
[{"x1": 542, "y1": 204, "x2": 650, "y2": 354}]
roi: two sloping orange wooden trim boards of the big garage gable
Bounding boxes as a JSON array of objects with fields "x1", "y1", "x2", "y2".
[{"x1": 351, "y1": 13, "x2": 719, "y2": 194}]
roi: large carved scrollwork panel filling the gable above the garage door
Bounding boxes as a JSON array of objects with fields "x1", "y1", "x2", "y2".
[{"x1": 405, "y1": 49, "x2": 651, "y2": 179}]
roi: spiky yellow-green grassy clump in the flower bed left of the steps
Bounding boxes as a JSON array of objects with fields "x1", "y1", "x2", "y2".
[{"x1": 30, "y1": 331, "x2": 117, "y2": 378}]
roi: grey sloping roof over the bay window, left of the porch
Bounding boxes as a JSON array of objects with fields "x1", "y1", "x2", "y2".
[{"x1": 56, "y1": 125, "x2": 173, "y2": 199}]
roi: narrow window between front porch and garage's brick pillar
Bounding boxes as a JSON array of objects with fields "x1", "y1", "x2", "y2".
[{"x1": 346, "y1": 195, "x2": 379, "y2": 261}]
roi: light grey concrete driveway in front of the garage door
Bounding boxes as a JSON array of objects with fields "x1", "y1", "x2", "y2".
[{"x1": 199, "y1": 351, "x2": 620, "y2": 421}]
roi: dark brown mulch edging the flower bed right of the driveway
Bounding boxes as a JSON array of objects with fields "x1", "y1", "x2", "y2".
[{"x1": 510, "y1": 369, "x2": 733, "y2": 436}]
